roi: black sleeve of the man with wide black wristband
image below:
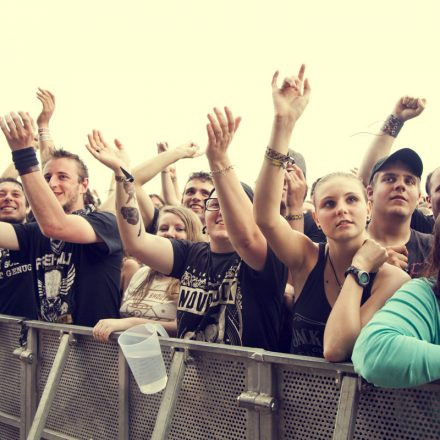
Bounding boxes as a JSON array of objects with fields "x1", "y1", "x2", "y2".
[{"x1": 84, "y1": 211, "x2": 122, "y2": 255}]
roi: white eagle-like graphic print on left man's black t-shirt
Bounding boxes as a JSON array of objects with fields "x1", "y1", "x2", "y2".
[{"x1": 36, "y1": 239, "x2": 76, "y2": 322}]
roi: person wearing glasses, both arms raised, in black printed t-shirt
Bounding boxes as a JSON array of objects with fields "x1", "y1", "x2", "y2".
[{"x1": 87, "y1": 108, "x2": 287, "y2": 351}]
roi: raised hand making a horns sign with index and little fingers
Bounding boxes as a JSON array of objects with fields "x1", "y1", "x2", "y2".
[{"x1": 272, "y1": 64, "x2": 311, "y2": 121}]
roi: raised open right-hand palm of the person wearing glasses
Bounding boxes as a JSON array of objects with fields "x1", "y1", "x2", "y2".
[{"x1": 206, "y1": 107, "x2": 241, "y2": 160}]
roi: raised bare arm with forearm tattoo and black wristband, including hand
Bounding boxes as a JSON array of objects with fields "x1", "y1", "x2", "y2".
[{"x1": 86, "y1": 130, "x2": 174, "y2": 275}]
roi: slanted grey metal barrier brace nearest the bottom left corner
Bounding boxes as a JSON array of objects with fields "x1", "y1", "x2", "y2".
[{"x1": 27, "y1": 333, "x2": 70, "y2": 440}]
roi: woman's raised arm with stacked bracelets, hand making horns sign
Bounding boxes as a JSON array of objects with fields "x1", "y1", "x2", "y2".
[{"x1": 254, "y1": 65, "x2": 316, "y2": 271}]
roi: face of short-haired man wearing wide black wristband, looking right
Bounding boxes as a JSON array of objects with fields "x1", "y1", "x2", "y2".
[{"x1": 43, "y1": 158, "x2": 88, "y2": 214}]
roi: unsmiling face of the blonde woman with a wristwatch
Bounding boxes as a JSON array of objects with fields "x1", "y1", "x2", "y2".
[{"x1": 314, "y1": 175, "x2": 369, "y2": 241}]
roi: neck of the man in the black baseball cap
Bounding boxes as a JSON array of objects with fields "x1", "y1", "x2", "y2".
[{"x1": 368, "y1": 214, "x2": 411, "y2": 246}]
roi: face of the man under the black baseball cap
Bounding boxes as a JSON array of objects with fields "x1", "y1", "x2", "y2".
[{"x1": 368, "y1": 161, "x2": 420, "y2": 219}]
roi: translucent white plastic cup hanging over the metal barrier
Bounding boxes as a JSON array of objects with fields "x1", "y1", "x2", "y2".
[{"x1": 118, "y1": 324, "x2": 168, "y2": 394}]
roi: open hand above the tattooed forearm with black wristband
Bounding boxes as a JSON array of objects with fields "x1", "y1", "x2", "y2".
[{"x1": 86, "y1": 130, "x2": 130, "y2": 172}]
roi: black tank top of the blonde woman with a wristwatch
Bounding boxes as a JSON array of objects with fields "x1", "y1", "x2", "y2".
[{"x1": 290, "y1": 243, "x2": 376, "y2": 357}]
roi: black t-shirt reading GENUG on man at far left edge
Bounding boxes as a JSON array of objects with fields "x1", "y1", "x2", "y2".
[{"x1": 0, "y1": 249, "x2": 38, "y2": 319}]
